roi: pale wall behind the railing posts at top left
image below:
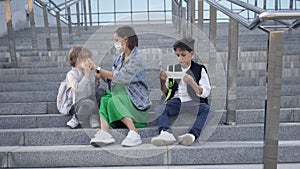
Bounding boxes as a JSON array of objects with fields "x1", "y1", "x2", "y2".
[{"x1": 0, "y1": 0, "x2": 56, "y2": 36}]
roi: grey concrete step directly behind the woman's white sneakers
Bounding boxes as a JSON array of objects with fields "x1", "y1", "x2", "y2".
[{"x1": 0, "y1": 123, "x2": 300, "y2": 146}]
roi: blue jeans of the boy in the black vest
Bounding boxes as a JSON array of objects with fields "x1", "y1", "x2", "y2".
[{"x1": 154, "y1": 98, "x2": 210, "y2": 139}]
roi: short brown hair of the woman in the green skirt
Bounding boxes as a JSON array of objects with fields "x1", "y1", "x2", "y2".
[{"x1": 115, "y1": 26, "x2": 139, "y2": 50}]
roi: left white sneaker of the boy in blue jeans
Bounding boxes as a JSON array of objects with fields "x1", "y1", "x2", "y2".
[{"x1": 151, "y1": 130, "x2": 176, "y2": 146}]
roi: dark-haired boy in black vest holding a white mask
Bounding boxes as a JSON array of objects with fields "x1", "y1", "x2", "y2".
[{"x1": 151, "y1": 38, "x2": 211, "y2": 146}]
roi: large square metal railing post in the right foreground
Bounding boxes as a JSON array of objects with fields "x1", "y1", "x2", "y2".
[{"x1": 263, "y1": 31, "x2": 284, "y2": 169}]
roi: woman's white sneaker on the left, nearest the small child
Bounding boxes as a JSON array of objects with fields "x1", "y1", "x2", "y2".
[{"x1": 90, "y1": 130, "x2": 116, "y2": 147}]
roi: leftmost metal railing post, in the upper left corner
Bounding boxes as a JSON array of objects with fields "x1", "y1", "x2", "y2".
[{"x1": 4, "y1": 1, "x2": 18, "y2": 67}]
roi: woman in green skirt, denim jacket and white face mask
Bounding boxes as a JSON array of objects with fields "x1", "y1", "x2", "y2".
[{"x1": 90, "y1": 26, "x2": 151, "y2": 147}]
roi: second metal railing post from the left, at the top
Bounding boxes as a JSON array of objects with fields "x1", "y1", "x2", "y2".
[{"x1": 28, "y1": 0, "x2": 38, "y2": 51}]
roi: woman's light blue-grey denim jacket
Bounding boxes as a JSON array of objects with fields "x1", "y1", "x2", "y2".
[{"x1": 111, "y1": 47, "x2": 152, "y2": 110}]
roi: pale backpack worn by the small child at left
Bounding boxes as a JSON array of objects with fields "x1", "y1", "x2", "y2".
[{"x1": 56, "y1": 80, "x2": 75, "y2": 115}]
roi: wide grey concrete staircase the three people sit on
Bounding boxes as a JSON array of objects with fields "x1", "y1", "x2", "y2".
[{"x1": 0, "y1": 24, "x2": 300, "y2": 168}]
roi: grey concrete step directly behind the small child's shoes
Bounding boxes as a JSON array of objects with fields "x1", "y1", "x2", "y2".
[{"x1": 0, "y1": 108, "x2": 300, "y2": 129}]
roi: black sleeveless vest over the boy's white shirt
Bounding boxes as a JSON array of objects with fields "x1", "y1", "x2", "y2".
[{"x1": 166, "y1": 61, "x2": 208, "y2": 104}]
